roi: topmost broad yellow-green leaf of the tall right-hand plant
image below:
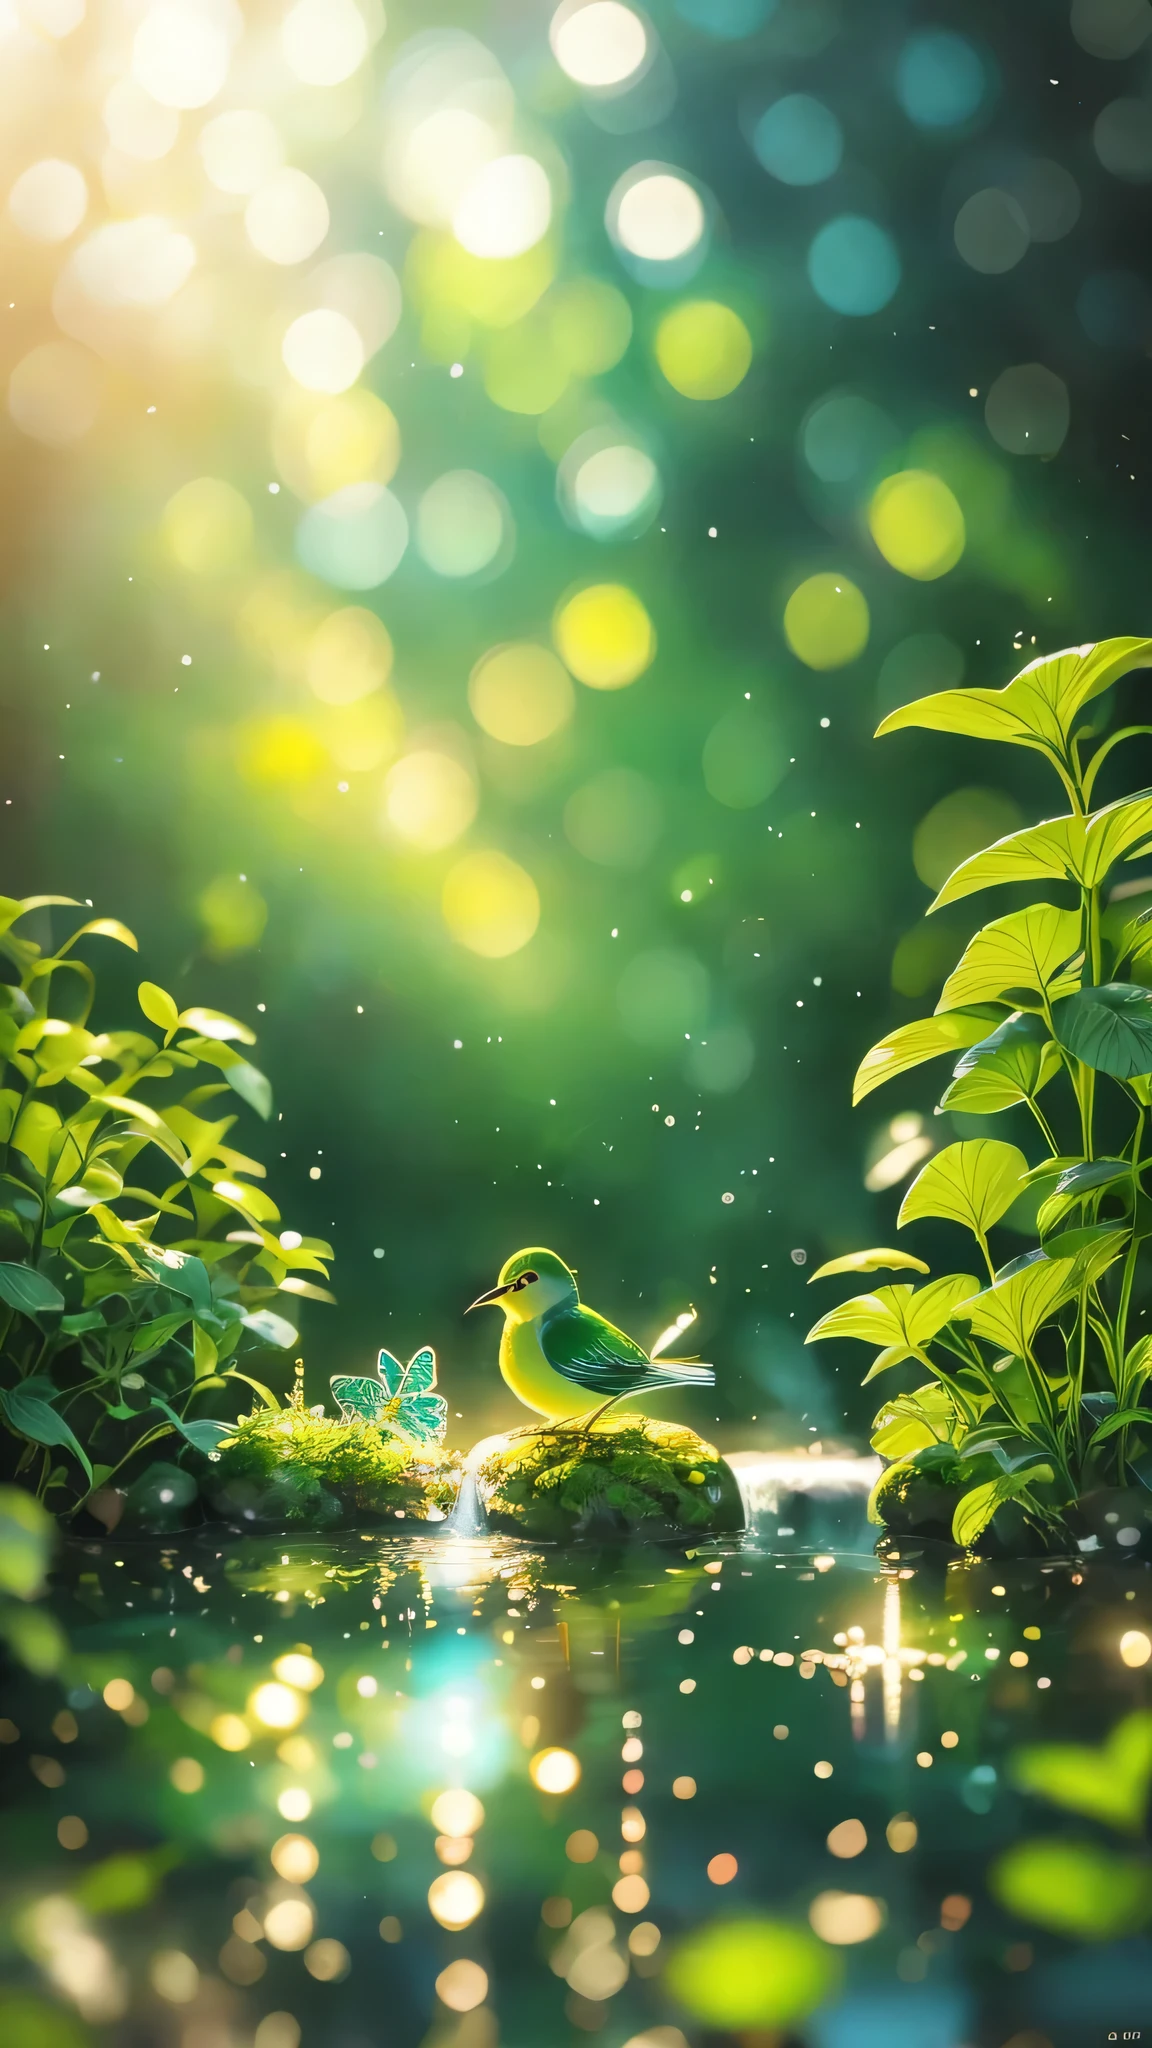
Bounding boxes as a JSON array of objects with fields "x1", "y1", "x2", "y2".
[{"x1": 875, "y1": 639, "x2": 1152, "y2": 758}]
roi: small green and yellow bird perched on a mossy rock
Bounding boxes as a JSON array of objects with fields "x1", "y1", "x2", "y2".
[{"x1": 469, "y1": 1247, "x2": 715, "y2": 1423}]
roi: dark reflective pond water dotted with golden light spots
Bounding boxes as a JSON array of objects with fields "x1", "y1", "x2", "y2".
[{"x1": 0, "y1": 1470, "x2": 1152, "y2": 2048}]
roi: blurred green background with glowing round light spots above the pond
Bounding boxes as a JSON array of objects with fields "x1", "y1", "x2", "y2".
[{"x1": 0, "y1": 0, "x2": 1152, "y2": 1446}]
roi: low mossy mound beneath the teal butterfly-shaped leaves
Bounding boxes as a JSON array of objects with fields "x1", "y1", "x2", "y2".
[{"x1": 201, "y1": 1409, "x2": 461, "y2": 1530}]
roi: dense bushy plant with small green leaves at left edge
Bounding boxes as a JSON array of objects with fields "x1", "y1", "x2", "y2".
[{"x1": 0, "y1": 897, "x2": 332, "y2": 1507}]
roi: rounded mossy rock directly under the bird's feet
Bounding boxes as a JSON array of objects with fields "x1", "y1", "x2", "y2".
[{"x1": 476, "y1": 1415, "x2": 744, "y2": 1542}]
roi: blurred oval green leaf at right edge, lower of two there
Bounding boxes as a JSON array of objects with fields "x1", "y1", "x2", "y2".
[{"x1": 988, "y1": 1835, "x2": 1152, "y2": 1942}]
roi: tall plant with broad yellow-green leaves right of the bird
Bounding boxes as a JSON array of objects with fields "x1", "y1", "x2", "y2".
[{"x1": 808, "y1": 639, "x2": 1152, "y2": 1544}]
